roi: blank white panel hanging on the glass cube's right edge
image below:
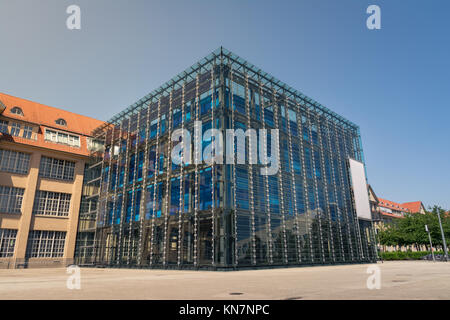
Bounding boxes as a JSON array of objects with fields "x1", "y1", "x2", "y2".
[{"x1": 348, "y1": 159, "x2": 372, "y2": 220}]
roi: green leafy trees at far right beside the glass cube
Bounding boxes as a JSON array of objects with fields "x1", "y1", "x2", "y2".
[{"x1": 378, "y1": 206, "x2": 450, "y2": 246}]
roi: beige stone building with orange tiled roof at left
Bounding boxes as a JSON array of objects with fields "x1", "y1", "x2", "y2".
[{"x1": 0, "y1": 93, "x2": 102, "y2": 268}]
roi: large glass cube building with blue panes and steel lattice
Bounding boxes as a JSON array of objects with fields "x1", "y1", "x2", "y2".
[{"x1": 76, "y1": 48, "x2": 377, "y2": 269}]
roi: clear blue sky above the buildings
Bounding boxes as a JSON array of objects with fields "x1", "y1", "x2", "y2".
[{"x1": 0, "y1": 0, "x2": 450, "y2": 208}]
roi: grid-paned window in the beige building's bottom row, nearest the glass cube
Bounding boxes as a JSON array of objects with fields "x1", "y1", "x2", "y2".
[{"x1": 26, "y1": 230, "x2": 66, "y2": 258}]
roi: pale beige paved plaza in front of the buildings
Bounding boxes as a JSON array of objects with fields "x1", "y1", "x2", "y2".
[{"x1": 0, "y1": 261, "x2": 450, "y2": 300}]
